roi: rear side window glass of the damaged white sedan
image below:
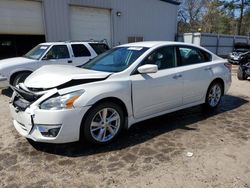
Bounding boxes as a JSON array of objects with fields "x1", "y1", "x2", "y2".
[{"x1": 178, "y1": 46, "x2": 212, "y2": 66}]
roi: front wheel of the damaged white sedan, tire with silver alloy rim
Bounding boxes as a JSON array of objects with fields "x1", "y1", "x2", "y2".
[{"x1": 81, "y1": 102, "x2": 125, "y2": 145}]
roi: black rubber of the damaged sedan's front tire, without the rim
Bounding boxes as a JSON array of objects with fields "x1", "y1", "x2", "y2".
[{"x1": 80, "y1": 102, "x2": 125, "y2": 145}]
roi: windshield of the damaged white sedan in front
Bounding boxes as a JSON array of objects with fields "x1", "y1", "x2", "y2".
[{"x1": 82, "y1": 47, "x2": 148, "y2": 72}]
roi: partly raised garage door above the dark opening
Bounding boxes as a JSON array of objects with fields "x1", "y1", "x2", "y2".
[{"x1": 0, "y1": 0, "x2": 44, "y2": 35}]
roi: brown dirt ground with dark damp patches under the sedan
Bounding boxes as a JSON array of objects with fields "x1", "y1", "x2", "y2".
[{"x1": 0, "y1": 75, "x2": 250, "y2": 188}]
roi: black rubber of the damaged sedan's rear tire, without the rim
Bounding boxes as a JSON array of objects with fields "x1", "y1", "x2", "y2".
[{"x1": 203, "y1": 81, "x2": 223, "y2": 111}]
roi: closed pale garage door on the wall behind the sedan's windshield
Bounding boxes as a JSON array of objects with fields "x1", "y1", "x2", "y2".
[{"x1": 70, "y1": 6, "x2": 111, "y2": 44}]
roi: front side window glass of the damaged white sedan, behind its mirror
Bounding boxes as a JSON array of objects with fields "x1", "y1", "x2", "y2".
[{"x1": 142, "y1": 46, "x2": 176, "y2": 70}]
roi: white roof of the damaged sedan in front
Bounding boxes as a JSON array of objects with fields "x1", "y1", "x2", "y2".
[{"x1": 118, "y1": 41, "x2": 205, "y2": 48}]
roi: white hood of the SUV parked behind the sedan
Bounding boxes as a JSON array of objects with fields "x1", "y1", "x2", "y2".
[{"x1": 0, "y1": 57, "x2": 36, "y2": 69}]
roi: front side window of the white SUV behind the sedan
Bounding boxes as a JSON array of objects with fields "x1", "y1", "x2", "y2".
[{"x1": 44, "y1": 45, "x2": 70, "y2": 59}]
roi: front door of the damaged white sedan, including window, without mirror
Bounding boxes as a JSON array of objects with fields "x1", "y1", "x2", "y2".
[{"x1": 131, "y1": 46, "x2": 183, "y2": 119}]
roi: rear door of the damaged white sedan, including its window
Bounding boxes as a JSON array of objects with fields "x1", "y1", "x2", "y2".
[{"x1": 177, "y1": 46, "x2": 213, "y2": 105}]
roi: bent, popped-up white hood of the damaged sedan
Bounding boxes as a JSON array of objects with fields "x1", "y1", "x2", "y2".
[{"x1": 24, "y1": 65, "x2": 112, "y2": 89}]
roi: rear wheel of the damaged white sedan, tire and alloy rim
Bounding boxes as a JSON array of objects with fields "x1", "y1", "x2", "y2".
[{"x1": 204, "y1": 81, "x2": 223, "y2": 110}]
